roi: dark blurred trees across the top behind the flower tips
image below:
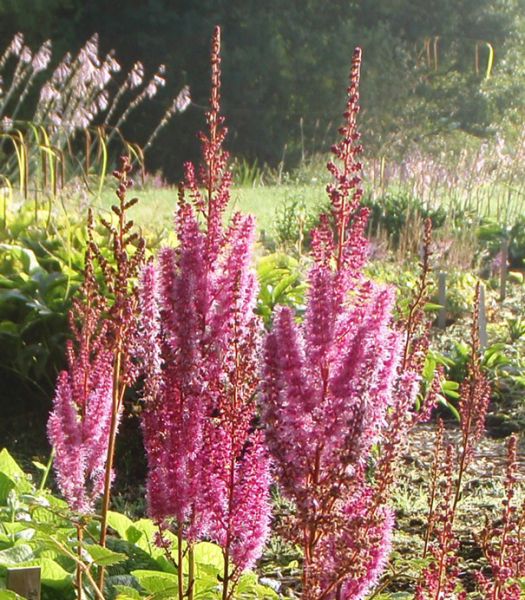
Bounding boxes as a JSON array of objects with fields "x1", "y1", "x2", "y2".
[{"x1": 0, "y1": 0, "x2": 525, "y2": 176}]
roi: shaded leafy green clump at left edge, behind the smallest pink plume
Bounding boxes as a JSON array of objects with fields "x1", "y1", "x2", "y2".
[{"x1": 0, "y1": 212, "x2": 86, "y2": 410}]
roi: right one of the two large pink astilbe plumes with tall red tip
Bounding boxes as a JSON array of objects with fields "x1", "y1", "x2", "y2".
[{"x1": 262, "y1": 49, "x2": 410, "y2": 600}]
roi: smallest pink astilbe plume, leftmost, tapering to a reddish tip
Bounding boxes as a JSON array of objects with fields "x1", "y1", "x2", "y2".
[{"x1": 48, "y1": 232, "x2": 113, "y2": 513}]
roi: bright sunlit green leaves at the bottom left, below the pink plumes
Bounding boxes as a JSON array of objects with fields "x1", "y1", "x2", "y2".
[{"x1": 0, "y1": 449, "x2": 278, "y2": 600}]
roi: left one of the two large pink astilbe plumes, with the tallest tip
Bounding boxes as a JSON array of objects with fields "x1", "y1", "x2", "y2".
[{"x1": 140, "y1": 28, "x2": 270, "y2": 599}]
